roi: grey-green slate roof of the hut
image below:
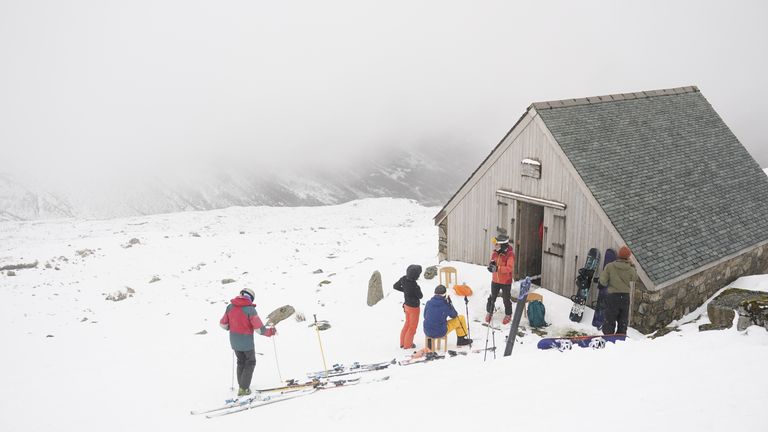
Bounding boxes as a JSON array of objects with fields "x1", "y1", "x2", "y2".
[{"x1": 532, "y1": 87, "x2": 768, "y2": 286}]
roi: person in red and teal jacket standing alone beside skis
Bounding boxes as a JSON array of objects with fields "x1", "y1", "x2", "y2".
[{"x1": 219, "y1": 288, "x2": 277, "y2": 396}]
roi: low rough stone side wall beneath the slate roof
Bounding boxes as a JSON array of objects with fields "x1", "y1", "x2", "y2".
[{"x1": 630, "y1": 245, "x2": 768, "y2": 334}]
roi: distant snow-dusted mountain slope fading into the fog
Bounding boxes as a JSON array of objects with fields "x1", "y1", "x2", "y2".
[{"x1": 0, "y1": 147, "x2": 482, "y2": 220}]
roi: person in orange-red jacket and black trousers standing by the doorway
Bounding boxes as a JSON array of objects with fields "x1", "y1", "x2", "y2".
[{"x1": 485, "y1": 234, "x2": 515, "y2": 324}]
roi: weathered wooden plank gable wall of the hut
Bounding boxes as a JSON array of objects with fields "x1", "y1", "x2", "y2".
[{"x1": 446, "y1": 112, "x2": 622, "y2": 296}]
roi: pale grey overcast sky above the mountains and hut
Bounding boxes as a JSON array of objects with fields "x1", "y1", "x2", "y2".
[{"x1": 0, "y1": 0, "x2": 768, "y2": 185}]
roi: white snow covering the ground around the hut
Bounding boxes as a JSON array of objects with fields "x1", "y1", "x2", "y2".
[{"x1": 0, "y1": 199, "x2": 768, "y2": 432}]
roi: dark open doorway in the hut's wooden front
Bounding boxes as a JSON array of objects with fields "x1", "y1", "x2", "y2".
[{"x1": 515, "y1": 201, "x2": 544, "y2": 284}]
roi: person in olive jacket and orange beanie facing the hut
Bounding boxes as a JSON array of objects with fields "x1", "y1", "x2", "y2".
[{"x1": 600, "y1": 246, "x2": 637, "y2": 335}]
